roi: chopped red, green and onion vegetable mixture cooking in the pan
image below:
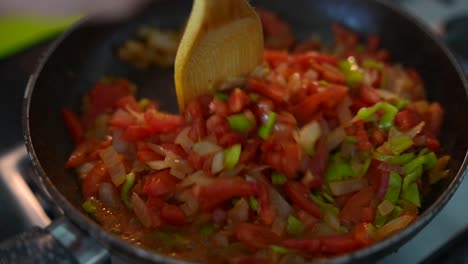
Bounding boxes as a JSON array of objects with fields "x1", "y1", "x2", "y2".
[{"x1": 63, "y1": 10, "x2": 449, "y2": 263}]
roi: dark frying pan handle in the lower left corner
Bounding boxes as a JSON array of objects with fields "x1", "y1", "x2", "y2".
[{"x1": 0, "y1": 217, "x2": 110, "y2": 264}]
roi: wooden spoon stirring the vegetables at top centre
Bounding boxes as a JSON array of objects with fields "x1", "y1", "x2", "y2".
[{"x1": 174, "y1": 0, "x2": 263, "y2": 112}]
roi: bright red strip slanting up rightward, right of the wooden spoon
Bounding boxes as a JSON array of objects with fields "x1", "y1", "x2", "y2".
[{"x1": 291, "y1": 84, "x2": 348, "y2": 123}]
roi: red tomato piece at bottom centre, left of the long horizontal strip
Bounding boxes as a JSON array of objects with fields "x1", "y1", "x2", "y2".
[{"x1": 235, "y1": 223, "x2": 280, "y2": 251}]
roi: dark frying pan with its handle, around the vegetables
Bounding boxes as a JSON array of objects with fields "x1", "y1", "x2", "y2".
[{"x1": 0, "y1": 0, "x2": 468, "y2": 263}]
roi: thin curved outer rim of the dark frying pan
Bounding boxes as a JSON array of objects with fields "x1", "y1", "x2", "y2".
[{"x1": 22, "y1": 0, "x2": 468, "y2": 263}]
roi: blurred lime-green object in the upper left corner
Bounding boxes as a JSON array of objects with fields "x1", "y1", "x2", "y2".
[{"x1": 0, "y1": 15, "x2": 81, "y2": 59}]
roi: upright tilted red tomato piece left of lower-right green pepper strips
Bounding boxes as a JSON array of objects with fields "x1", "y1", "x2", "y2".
[{"x1": 340, "y1": 186, "x2": 375, "y2": 225}]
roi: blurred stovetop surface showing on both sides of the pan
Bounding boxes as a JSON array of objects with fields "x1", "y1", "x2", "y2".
[{"x1": 0, "y1": 0, "x2": 468, "y2": 264}]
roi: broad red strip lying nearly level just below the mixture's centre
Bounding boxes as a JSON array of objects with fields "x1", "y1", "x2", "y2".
[{"x1": 194, "y1": 179, "x2": 257, "y2": 212}]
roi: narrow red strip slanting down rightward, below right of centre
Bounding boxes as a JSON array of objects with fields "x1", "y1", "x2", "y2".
[{"x1": 284, "y1": 181, "x2": 321, "y2": 218}]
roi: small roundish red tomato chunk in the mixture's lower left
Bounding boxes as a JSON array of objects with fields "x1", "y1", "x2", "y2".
[{"x1": 143, "y1": 170, "x2": 178, "y2": 196}]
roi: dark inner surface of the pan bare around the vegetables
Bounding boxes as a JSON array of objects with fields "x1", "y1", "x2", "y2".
[{"x1": 26, "y1": 0, "x2": 468, "y2": 260}]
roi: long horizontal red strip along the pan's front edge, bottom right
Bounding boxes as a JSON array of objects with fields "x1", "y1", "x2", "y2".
[{"x1": 282, "y1": 234, "x2": 361, "y2": 254}]
